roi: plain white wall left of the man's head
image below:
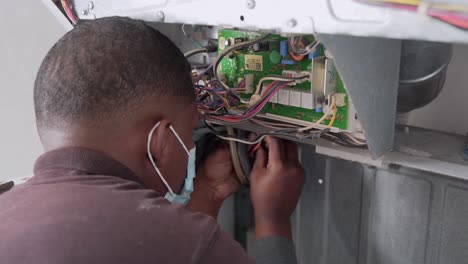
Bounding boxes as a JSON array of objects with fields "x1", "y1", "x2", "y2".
[{"x1": 0, "y1": 0, "x2": 65, "y2": 181}]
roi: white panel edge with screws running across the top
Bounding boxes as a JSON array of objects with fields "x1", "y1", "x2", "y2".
[{"x1": 70, "y1": 0, "x2": 468, "y2": 43}]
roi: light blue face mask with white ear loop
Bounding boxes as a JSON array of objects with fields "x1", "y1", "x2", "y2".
[{"x1": 147, "y1": 122, "x2": 196, "y2": 205}]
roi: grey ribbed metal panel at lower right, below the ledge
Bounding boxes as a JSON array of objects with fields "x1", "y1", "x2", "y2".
[{"x1": 293, "y1": 146, "x2": 468, "y2": 264}]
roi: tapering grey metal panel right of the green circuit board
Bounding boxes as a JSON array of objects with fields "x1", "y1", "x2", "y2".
[{"x1": 317, "y1": 34, "x2": 401, "y2": 158}]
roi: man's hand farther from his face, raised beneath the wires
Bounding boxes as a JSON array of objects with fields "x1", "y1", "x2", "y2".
[{"x1": 250, "y1": 137, "x2": 304, "y2": 239}]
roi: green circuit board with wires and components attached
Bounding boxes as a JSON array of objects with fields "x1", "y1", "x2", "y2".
[{"x1": 218, "y1": 29, "x2": 349, "y2": 130}]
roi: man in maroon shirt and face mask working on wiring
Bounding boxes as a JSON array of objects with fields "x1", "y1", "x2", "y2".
[{"x1": 0, "y1": 18, "x2": 303, "y2": 264}]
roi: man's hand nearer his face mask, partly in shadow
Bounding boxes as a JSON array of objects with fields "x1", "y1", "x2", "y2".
[{"x1": 187, "y1": 143, "x2": 240, "y2": 218}]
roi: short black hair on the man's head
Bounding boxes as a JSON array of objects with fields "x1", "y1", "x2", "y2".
[{"x1": 34, "y1": 17, "x2": 195, "y2": 128}]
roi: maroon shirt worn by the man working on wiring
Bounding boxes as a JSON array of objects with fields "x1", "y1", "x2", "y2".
[{"x1": 0, "y1": 148, "x2": 256, "y2": 264}]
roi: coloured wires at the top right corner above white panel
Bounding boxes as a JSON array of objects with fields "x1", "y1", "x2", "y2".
[{"x1": 358, "y1": 0, "x2": 468, "y2": 29}]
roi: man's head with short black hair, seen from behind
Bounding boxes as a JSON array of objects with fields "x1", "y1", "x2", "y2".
[{"x1": 34, "y1": 17, "x2": 196, "y2": 192}]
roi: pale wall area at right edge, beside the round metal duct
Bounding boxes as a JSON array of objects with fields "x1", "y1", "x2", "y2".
[{"x1": 409, "y1": 45, "x2": 468, "y2": 135}]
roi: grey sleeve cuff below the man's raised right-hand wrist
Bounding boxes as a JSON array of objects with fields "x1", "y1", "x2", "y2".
[{"x1": 251, "y1": 237, "x2": 297, "y2": 264}]
